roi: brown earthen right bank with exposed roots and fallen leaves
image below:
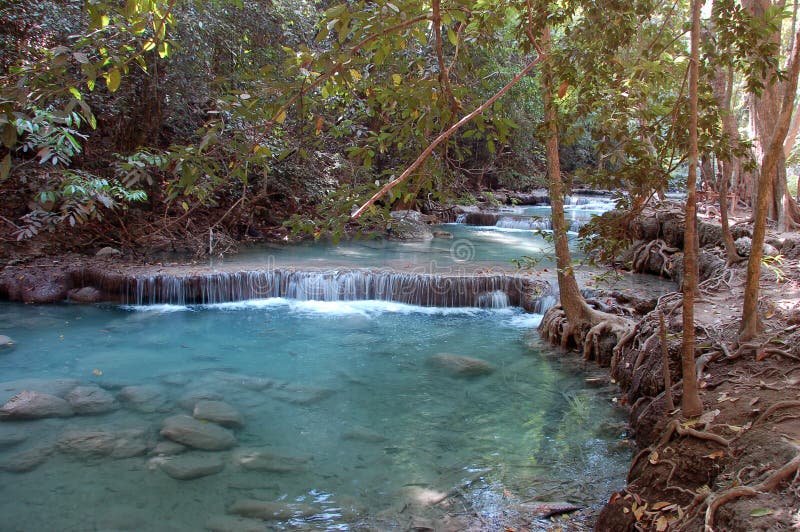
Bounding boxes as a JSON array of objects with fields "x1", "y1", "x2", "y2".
[{"x1": 0, "y1": 206, "x2": 800, "y2": 532}]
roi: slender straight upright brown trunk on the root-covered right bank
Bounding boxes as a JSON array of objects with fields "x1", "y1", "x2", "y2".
[{"x1": 681, "y1": 0, "x2": 703, "y2": 418}]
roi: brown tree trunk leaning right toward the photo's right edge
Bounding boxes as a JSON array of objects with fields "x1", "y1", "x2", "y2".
[{"x1": 739, "y1": 25, "x2": 800, "y2": 341}]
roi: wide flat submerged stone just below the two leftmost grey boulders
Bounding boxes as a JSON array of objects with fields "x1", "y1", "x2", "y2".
[{"x1": 58, "y1": 429, "x2": 148, "y2": 458}]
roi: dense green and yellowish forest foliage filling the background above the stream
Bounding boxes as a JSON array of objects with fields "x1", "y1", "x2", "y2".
[{"x1": 0, "y1": 0, "x2": 800, "y2": 247}]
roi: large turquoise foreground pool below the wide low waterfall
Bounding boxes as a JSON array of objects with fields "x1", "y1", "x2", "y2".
[{"x1": 0, "y1": 299, "x2": 630, "y2": 531}]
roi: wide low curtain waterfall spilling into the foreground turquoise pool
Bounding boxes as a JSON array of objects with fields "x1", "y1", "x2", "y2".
[{"x1": 75, "y1": 269, "x2": 546, "y2": 309}]
